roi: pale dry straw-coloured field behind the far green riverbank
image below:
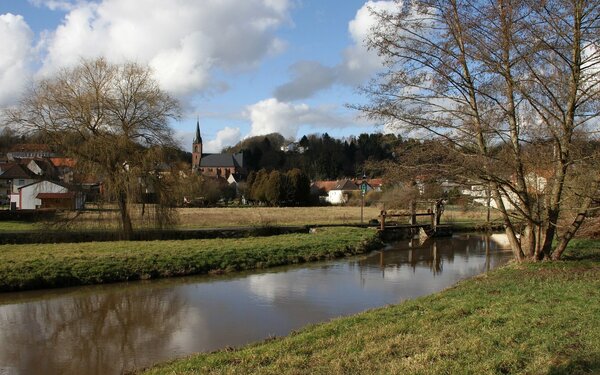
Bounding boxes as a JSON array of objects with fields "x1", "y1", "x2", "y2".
[{"x1": 0, "y1": 206, "x2": 497, "y2": 232}]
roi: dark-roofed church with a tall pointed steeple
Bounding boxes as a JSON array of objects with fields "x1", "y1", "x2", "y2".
[{"x1": 192, "y1": 120, "x2": 246, "y2": 182}]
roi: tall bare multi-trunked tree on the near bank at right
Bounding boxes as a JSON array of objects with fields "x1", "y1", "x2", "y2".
[{"x1": 358, "y1": 0, "x2": 600, "y2": 260}]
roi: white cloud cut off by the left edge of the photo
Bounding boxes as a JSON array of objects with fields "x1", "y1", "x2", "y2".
[{"x1": 0, "y1": 13, "x2": 33, "y2": 107}]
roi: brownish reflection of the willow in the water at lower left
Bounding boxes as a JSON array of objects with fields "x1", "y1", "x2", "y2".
[{"x1": 0, "y1": 288, "x2": 185, "y2": 374}]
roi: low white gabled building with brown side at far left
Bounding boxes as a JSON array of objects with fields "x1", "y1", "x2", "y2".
[{"x1": 11, "y1": 181, "x2": 85, "y2": 210}]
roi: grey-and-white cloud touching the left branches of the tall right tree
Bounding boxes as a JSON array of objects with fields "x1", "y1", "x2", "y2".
[{"x1": 275, "y1": 1, "x2": 400, "y2": 100}]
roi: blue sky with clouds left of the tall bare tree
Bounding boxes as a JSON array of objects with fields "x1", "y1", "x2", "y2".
[{"x1": 0, "y1": 0, "x2": 396, "y2": 152}]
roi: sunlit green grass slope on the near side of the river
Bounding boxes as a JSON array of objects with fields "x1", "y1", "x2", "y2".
[{"x1": 148, "y1": 241, "x2": 600, "y2": 374}]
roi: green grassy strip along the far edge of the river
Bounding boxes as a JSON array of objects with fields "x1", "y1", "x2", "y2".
[{"x1": 0, "y1": 228, "x2": 379, "y2": 291}]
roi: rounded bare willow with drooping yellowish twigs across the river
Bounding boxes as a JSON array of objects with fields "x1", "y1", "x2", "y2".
[{"x1": 7, "y1": 58, "x2": 179, "y2": 238}]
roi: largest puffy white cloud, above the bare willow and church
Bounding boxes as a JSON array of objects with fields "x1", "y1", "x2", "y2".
[{"x1": 34, "y1": 0, "x2": 290, "y2": 95}]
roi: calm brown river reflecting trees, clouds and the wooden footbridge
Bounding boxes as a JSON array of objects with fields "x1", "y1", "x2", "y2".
[{"x1": 0, "y1": 235, "x2": 511, "y2": 375}]
